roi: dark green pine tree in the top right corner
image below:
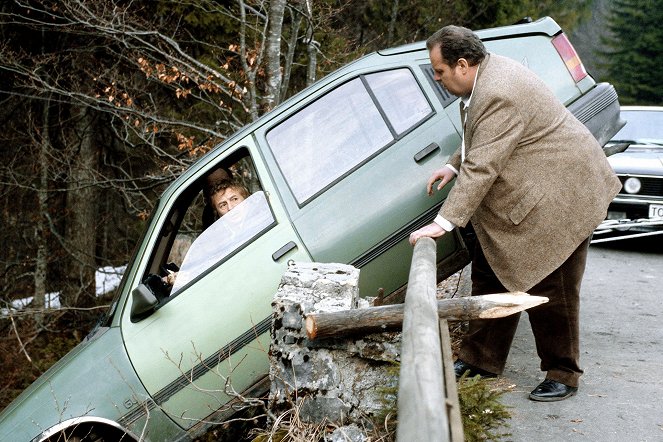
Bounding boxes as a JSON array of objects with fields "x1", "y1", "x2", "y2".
[{"x1": 600, "y1": 0, "x2": 663, "y2": 105}]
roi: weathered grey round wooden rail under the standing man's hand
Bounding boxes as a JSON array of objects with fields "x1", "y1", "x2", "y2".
[{"x1": 396, "y1": 238, "x2": 449, "y2": 442}]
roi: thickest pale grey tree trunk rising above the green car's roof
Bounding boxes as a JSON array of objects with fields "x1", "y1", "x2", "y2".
[{"x1": 263, "y1": 0, "x2": 287, "y2": 112}]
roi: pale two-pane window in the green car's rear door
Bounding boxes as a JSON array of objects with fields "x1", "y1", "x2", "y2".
[{"x1": 267, "y1": 69, "x2": 432, "y2": 204}]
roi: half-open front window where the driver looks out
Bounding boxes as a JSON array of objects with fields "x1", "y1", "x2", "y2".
[{"x1": 145, "y1": 148, "x2": 275, "y2": 298}]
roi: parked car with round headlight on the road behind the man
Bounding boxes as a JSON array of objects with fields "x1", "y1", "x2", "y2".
[{"x1": 597, "y1": 106, "x2": 663, "y2": 241}]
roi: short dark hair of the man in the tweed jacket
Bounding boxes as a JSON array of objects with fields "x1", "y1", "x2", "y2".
[{"x1": 426, "y1": 25, "x2": 487, "y2": 68}]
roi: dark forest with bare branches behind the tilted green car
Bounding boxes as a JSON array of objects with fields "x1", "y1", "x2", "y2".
[{"x1": 0, "y1": 0, "x2": 663, "y2": 409}]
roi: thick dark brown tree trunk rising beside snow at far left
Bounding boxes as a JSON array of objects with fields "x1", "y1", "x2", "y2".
[{"x1": 62, "y1": 105, "x2": 98, "y2": 306}]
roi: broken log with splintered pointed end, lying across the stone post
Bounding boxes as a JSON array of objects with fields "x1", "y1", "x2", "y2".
[{"x1": 306, "y1": 292, "x2": 548, "y2": 339}]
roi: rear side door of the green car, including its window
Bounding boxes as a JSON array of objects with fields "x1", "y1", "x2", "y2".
[{"x1": 256, "y1": 65, "x2": 462, "y2": 296}]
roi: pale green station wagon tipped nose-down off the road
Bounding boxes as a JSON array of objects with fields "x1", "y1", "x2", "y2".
[{"x1": 0, "y1": 18, "x2": 622, "y2": 441}]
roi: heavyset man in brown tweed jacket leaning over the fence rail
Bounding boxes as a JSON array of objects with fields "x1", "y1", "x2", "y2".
[{"x1": 410, "y1": 26, "x2": 621, "y2": 401}]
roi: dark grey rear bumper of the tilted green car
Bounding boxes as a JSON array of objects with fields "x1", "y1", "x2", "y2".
[{"x1": 569, "y1": 83, "x2": 626, "y2": 146}]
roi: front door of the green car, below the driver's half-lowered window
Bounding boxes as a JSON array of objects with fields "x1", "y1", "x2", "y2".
[{"x1": 122, "y1": 135, "x2": 310, "y2": 429}]
